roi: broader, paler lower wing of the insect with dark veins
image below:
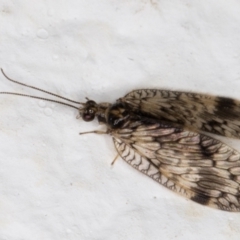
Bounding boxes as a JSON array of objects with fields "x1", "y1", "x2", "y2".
[{"x1": 112, "y1": 123, "x2": 240, "y2": 211}]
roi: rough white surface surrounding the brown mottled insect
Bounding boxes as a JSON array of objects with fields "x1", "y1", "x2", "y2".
[{"x1": 0, "y1": 0, "x2": 240, "y2": 240}]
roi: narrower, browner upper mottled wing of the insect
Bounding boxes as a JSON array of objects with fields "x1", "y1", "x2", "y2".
[{"x1": 119, "y1": 89, "x2": 240, "y2": 138}]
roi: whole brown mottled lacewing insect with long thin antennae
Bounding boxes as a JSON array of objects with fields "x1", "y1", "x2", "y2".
[{"x1": 0, "y1": 69, "x2": 240, "y2": 212}]
